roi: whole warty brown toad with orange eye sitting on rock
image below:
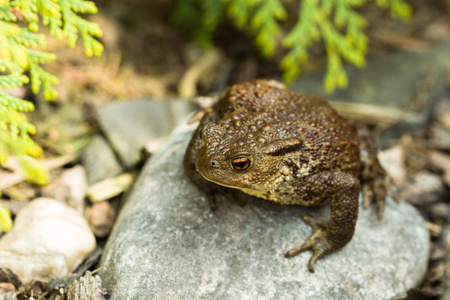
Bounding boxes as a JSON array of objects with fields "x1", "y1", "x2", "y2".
[{"x1": 184, "y1": 80, "x2": 386, "y2": 272}]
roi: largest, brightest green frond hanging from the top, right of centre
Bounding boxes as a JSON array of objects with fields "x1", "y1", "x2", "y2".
[{"x1": 280, "y1": 0, "x2": 368, "y2": 92}]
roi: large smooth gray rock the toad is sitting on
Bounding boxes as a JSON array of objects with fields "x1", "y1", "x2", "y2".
[{"x1": 101, "y1": 122, "x2": 429, "y2": 299}]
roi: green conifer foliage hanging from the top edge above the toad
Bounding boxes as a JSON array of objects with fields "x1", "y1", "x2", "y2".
[{"x1": 174, "y1": 0, "x2": 411, "y2": 92}]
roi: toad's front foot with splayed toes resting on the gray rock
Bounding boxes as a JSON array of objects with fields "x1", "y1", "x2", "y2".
[{"x1": 285, "y1": 216, "x2": 336, "y2": 273}]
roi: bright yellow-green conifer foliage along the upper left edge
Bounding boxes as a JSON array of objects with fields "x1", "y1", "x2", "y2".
[{"x1": 0, "y1": 0, "x2": 103, "y2": 184}]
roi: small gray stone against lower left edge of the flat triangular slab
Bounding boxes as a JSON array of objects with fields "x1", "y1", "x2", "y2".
[{"x1": 81, "y1": 134, "x2": 124, "y2": 185}]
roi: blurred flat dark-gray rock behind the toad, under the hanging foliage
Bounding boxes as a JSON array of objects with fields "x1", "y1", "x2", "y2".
[{"x1": 291, "y1": 41, "x2": 450, "y2": 109}]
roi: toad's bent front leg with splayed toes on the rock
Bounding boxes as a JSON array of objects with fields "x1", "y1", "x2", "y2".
[{"x1": 285, "y1": 172, "x2": 360, "y2": 272}]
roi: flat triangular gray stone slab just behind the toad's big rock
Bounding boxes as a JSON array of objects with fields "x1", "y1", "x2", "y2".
[{"x1": 98, "y1": 100, "x2": 194, "y2": 169}]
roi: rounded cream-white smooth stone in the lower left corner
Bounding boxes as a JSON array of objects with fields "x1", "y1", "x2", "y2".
[{"x1": 0, "y1": 198, "x2": 96, "y2": 284}]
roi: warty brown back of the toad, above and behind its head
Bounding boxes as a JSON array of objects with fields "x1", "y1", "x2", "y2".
[{"x1": 209, "y1": 81, "x2": 360, "y2": 176}]
